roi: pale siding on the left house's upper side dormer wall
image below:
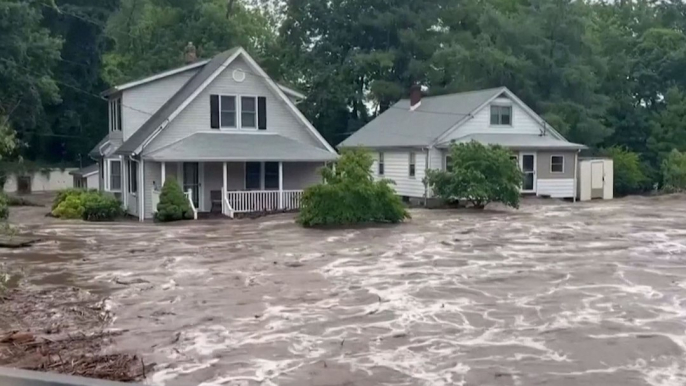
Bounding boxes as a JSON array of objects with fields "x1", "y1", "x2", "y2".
[{"x1": 121, "y1": 69, "x2": 198, "y2": 140}]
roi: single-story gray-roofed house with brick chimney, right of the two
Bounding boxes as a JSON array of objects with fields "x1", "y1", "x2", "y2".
[{"x1": 339, "y1": 87, "x2": 585, "y2": 199}]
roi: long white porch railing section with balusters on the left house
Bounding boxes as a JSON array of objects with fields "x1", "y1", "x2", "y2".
[{"x1": 226, "y1": 190, "x2": 303, "y2": 213}]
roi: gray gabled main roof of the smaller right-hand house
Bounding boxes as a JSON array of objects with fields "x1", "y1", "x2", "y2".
[{"x1": 338, "y1": 87, "x2": 564, "y2": 147}]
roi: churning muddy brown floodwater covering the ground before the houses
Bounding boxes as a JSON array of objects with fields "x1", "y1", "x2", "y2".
[{"x1": 2, "y1": 196, "x2": 686, "y2": 386}]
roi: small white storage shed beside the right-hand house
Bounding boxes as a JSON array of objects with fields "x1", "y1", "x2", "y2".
[{"x1": 578, "y1": 158, "x2": 614, "y2": 201}]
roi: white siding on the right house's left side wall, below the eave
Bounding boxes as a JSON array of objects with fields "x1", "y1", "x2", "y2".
[{"x1": 382, "y1": 149, "x2": 426, "y2": 197}]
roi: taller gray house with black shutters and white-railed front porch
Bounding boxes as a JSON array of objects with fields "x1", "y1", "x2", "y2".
[{"x1": 90, "y1": 47, "x2": 338, "y2": 221}]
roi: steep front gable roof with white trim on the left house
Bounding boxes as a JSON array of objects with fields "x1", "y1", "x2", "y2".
[{"x1": 117, "y1": 47, "x2": 336, "y2": 155}]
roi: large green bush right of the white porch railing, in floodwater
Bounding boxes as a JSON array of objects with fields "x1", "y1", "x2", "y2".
[{"x1": 298, "y1": 149, "x2": 410, "y2": 227}]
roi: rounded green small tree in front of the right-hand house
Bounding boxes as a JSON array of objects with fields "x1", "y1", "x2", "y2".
[{"x1": 425, "y1": 141, "x2": 523, "y2": 208}]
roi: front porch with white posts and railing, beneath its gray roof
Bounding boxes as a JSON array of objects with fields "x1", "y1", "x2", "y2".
[{"x1": 146, "y1": 161, "x2": 324, "y2": 218}]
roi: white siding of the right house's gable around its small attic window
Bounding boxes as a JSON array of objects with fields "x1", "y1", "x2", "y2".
[{"x1": 441, "y1": 98, "x2": 542, "y2": 141}]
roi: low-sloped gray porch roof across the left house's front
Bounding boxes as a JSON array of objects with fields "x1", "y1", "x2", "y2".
[{"x1": 143, "y1": 132, "x2": 338, "y2": 162}]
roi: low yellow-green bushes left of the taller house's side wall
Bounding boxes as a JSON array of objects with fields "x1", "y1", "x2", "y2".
[{"x1": 52, "y1": 189, "x2": 123, "y2": 221}]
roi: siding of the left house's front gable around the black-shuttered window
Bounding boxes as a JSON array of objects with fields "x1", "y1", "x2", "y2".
[{"x1": 144, "y1": 58, "x2": 324, "y2": 154}]
